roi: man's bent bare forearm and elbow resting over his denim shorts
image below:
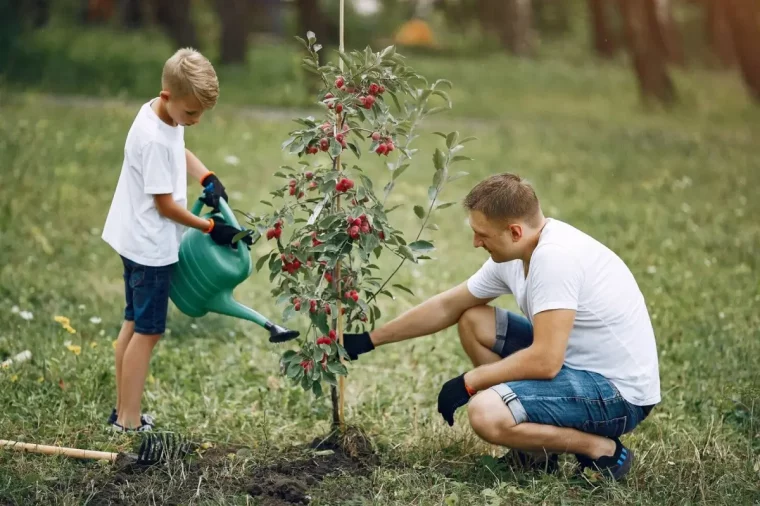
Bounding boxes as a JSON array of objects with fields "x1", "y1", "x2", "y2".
[{"x1": 464, "y1": 309, "x2": 575, "y2": 391}]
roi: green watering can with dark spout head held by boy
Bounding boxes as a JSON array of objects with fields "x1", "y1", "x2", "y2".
[{"x1": 169, "y1": 195, "x2": 299, "y2": 343}]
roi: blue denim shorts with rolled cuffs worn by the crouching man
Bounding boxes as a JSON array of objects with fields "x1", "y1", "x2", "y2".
[{"x1": 491, "y1": 308, "x2": 652, "y2": 438}]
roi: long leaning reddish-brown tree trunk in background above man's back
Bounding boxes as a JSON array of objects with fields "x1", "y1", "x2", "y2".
[{"x1": 619, "y1": 0, "x2": 676, "y2": 104}]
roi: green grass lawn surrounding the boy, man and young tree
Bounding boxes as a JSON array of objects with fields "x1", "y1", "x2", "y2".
[{"x1": 0, "y1": 61, "x2": 760, "y2": 505}]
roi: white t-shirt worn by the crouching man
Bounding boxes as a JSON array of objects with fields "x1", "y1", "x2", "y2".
[{"x1": 467, "y1": 218, "x2": 660, "y2": 406}]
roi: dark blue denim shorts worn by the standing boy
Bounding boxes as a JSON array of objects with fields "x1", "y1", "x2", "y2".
[{"x1": 121, "y1": 257, "x2": 172, "y2": 335}]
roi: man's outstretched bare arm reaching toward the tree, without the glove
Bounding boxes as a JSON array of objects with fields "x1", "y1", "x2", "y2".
[{"x1": 370, "y1": 282, "x2": 493, "y2": 347}]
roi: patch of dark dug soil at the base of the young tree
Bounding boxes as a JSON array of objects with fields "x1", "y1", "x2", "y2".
[{"x1": 82, "y1": 428, "x2": 377, "y2": 506}]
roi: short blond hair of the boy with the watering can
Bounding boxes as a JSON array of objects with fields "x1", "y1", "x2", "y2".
[{"x1": 161, "y1": 47, "x2": 219, "y2": 109}]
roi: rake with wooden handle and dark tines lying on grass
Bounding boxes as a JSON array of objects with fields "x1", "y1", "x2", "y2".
[{"x1": 0, "y1": 432, "x2": 193, "y2": 466}]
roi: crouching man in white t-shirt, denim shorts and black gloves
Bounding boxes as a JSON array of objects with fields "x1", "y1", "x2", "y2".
[{"x1": 344, "y1": 174, "x2": 660, "y2": 480}]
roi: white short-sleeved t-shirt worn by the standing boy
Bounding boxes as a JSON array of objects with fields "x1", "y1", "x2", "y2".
[{"x1": 102, "y1": 97, "x2": 187, "y2": 266}]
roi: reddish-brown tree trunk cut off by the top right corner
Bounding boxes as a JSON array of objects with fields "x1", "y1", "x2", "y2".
[{"x1": 722, "y1": 0, "x2": 760, "y2": 101}]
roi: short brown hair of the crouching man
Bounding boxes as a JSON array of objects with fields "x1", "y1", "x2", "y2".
[{"x1": 464, "y1": 172, "x2": 541, "y2": 225}]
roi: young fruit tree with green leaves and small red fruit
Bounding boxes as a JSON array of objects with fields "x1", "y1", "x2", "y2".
[{"x1": 240, "y1": 32, "x2": 474, "y2": 426}]
